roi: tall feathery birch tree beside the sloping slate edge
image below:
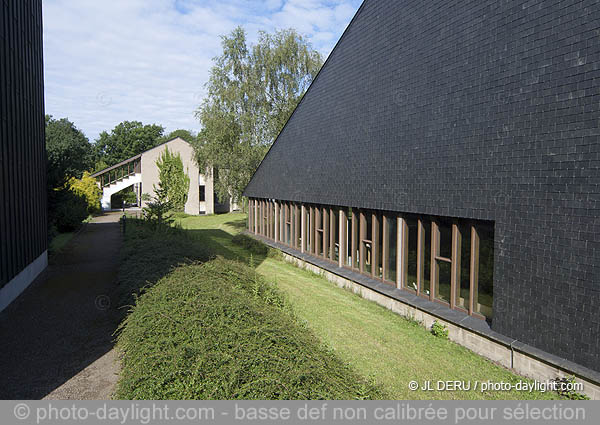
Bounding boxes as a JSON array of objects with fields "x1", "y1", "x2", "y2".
[{"x1": 195, "y1": 27, "x2": 323, "y2": 202}]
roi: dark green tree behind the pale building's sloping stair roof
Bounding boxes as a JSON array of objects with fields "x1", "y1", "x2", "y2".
[{"x1": 95, "y1": 121, "x2": 165, "y2": 166}]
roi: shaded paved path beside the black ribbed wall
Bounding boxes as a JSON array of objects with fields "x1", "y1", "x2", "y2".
[{"x1": 0, "y1": 213, "x2": 122, "y2": 399}]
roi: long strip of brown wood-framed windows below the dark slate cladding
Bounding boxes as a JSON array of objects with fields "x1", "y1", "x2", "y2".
[{"x1": 260, "y1": 200, "x2": 494, "y2": 320}]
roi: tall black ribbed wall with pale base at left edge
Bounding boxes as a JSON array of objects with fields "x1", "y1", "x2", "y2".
[{"x1": 0, "y1": 0, "x2": 48, "y2": 311}]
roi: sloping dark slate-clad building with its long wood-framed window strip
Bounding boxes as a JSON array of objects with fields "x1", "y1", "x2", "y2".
[{"x1": 245, "y1": 0, "x2": 600, "y2": 372}]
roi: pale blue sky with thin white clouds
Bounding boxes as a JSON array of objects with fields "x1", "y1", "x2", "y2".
[{"x1": 42, "y1": 0, "x2": 361, "y2": 142}]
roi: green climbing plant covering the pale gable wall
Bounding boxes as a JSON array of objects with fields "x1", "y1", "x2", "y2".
[{"x1": 154, "y1": 148, "x2": 190, "y2": 211}]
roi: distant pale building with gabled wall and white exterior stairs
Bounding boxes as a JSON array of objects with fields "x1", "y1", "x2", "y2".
[{"x1": 92, "y1": 137, "x2": 230, "y2": 215}]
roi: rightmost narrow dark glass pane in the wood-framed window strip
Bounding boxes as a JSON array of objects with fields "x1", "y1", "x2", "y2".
[{"x1": 475, "y1": 225, "x2": 494, "y2": 319}]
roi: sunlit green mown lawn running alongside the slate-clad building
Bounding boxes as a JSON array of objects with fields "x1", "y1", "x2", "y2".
[{"x1": 176, "y1": 213, "x2": 558, "y2": 399}]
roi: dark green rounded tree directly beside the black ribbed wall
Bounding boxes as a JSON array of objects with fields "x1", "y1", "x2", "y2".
[{"x1": 46, "y1": 115, "x2": 94, "y2": 188}]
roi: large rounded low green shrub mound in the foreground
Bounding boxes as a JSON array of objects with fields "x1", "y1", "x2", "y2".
[{"x1": 116, "y1": 255, "x2": 384, "y2": 399}]
